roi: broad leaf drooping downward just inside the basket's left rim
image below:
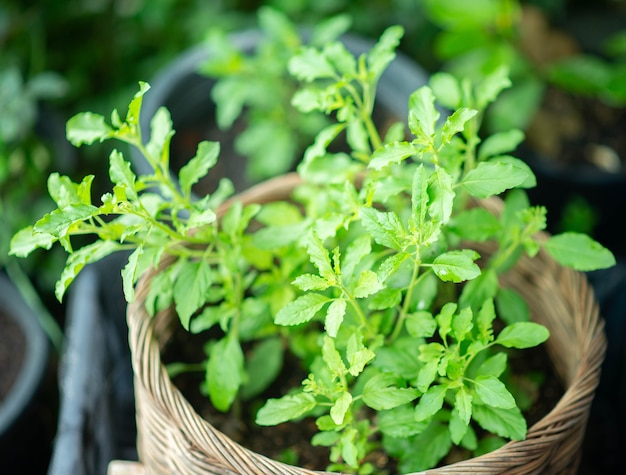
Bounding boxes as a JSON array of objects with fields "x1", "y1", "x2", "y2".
[{"x1": 174, "y1": 260, "x2": 213, "y2": 330}]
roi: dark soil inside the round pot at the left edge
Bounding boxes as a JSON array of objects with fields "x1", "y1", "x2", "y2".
[{"x1": 0, "y1": 310, "x2": 26, "y2": 403}]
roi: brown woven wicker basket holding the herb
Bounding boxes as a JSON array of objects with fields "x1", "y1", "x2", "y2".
[{"x1": 128, "y1": 175, "x2": 606, "y2": 475}]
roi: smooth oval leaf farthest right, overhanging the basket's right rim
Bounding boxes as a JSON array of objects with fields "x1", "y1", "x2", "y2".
[{"x1": 542, "y1": 233, "x2": 615, "y2": 271}]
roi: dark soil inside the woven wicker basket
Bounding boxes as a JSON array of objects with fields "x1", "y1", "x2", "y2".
[{"x1": 162, "y1": 322, "x2": 563, "y2": 474}]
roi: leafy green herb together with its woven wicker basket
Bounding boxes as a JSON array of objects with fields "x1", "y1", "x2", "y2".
[{"x1": 12, "y1": 27, "x2": 614, "y2": 474}]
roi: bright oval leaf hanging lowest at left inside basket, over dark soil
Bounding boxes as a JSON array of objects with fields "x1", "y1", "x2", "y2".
[{"x1": 206, "y1": 336, "x2": 244, "y2": 412}]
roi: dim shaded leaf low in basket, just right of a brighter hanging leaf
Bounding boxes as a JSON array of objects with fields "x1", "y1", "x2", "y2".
[{"x1": 240, "y1": 338, "x2": 284, "y2": 400}]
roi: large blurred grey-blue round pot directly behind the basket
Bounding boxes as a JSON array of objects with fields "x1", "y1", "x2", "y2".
[{"x1": 131, "y1": 30, "x2": 428, "y2": 196}]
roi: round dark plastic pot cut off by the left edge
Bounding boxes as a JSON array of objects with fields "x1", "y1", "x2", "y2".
[{"x1": 0, "y1": 272, "x2": 51, "y2": 473}]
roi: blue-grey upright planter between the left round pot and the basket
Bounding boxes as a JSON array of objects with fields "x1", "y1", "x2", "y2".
[{"x1": 48, "y1": 255, "x2": 137, "y2": 475}]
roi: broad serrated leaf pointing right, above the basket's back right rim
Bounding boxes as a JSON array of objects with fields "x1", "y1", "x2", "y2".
[{"x1": 460, "y1": 161, "x2": 529, "y2": 198}]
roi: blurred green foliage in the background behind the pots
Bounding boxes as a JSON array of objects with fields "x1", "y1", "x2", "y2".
[{"x1": 0, "y1": 0, "x2": 626, "y2": 330}]
